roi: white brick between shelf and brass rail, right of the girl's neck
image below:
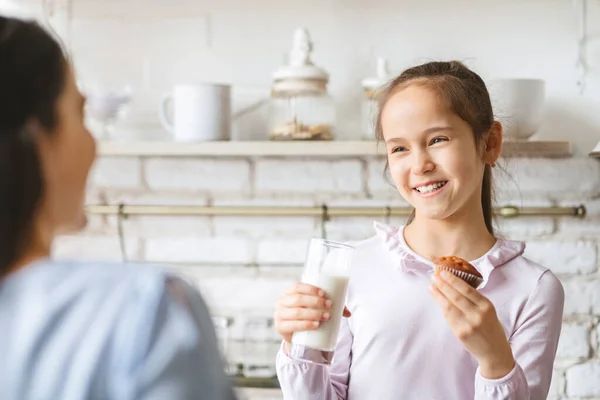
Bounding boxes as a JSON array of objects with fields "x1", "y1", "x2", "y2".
[{"x1": 496, "y1": 157, "x2": 600, "y2": 200}]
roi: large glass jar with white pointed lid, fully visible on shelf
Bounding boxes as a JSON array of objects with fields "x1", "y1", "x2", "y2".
[{"x1": 269, "y1": 28, "x2": 336, "y2": 140}]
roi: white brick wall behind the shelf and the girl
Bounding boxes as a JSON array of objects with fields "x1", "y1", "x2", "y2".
[{"x1": 10, "y1": 0, "x2": 600, "y2": 394}]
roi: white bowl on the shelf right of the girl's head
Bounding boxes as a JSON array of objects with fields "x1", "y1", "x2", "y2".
[{"x1": 488, "y1": 78, "x2": 546, "y2": 140}]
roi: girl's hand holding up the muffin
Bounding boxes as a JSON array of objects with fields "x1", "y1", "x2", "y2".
[{"x1": 429, "y1": 271, "x2": 515, "y2": 379}]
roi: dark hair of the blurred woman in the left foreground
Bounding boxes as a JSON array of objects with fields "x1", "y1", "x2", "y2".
[{"x1": 0, "y1": 16, "x2": 66, "y2": 275}]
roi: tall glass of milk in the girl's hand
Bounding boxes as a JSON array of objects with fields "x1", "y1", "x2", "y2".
[{"x1": 290, "y1": 238, "x2": 354, "y2": 365}]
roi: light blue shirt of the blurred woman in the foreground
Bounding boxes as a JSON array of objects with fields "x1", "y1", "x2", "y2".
[{"x1": 0, "y1": 260, "x2": 235, "y2": 400}]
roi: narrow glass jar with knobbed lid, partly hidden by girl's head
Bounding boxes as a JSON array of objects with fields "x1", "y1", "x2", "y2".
[{"x1": 361, "y1": 57, "x2": 390, "y2": 140}]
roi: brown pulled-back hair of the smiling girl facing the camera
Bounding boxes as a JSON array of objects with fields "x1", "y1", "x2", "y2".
[{"x1": 376, "y1": 61, "x2": 494, "y2": 235}]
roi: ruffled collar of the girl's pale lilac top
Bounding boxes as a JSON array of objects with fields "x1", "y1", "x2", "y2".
[{"x1": 374, "y1": 222, "x2": 525, "y2": 289}]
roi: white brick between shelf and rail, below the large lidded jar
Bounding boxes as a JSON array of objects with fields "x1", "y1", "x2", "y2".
[{"x1": 255, "y1": 159, "x2": 363, "y2": 193}]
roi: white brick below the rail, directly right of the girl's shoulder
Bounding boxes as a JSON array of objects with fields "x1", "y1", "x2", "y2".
[{"x1": 525, "y1": 241, "x2": 597, "y2": 274}]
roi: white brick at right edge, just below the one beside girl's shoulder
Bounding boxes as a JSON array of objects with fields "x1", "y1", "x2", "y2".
[{"x1": 563, "y1": 278, "x2": 600, "y2": 316}]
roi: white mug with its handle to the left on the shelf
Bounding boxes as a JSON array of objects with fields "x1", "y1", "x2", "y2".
[{"x1": 158, "y1": 83, "x2": 231, "y2": 142}]
